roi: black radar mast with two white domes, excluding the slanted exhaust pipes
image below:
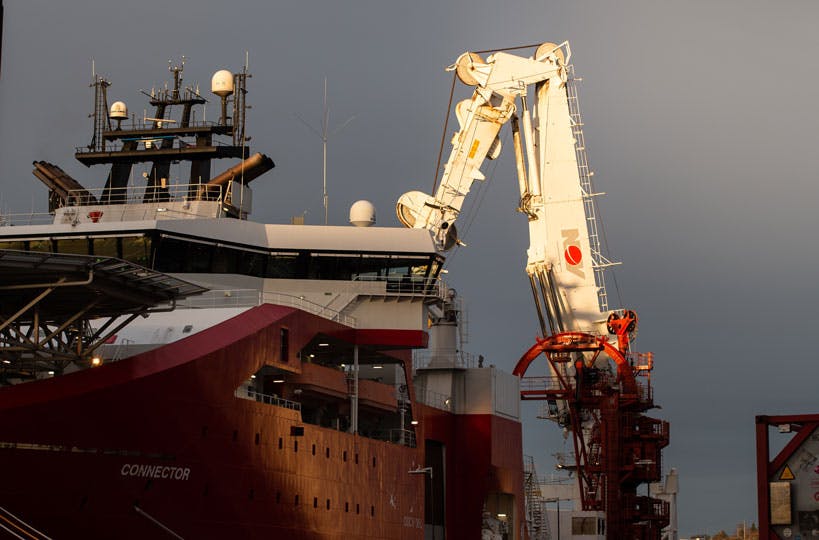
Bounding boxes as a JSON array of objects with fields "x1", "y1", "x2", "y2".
[{"x1": 75, "y1": 60, "x2": 273, "y2": 214}]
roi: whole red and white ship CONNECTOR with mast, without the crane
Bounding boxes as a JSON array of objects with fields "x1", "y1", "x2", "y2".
[{"x1": 0, "y1": 57, "x2": 529, "y2": 540}]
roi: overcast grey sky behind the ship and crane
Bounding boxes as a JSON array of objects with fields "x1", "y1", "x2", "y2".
[{"x1": 0, "y1": 0, "x2": 819, "y2": 536}]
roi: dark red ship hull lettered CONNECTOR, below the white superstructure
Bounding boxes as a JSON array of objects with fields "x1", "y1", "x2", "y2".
[{"x1": 0, "y1": 305, "x2": 523, "y2": 539}]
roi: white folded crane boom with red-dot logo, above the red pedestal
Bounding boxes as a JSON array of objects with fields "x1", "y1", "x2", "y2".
[{"x1": 396, "y1": 43, "x2": 606, "y2": 335}]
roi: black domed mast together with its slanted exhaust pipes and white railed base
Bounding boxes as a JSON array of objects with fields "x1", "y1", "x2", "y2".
[{"x1": 34, "y1": 56, "x2": 274, "y2": 219}]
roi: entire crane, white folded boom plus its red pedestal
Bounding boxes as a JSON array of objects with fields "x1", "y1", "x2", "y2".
[{"x1": 396, "y1": 42, "x2": 668, "y2": 540}]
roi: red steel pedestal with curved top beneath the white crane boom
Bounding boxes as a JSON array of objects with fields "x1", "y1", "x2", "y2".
[{"x1": 513, "y1": 332, "x2": 670, "y2": 540}]
